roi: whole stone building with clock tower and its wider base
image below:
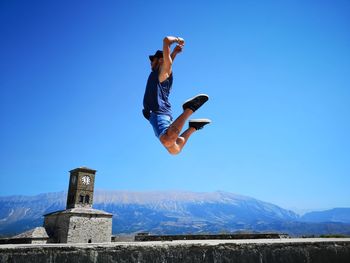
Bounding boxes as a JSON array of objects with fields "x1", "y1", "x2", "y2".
[{"x1": 44, "y1": 167, "x2": 112, "y2": 243}]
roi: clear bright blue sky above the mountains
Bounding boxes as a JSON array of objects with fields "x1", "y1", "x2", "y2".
[{"x1": 0, "y1": 0, "x2": 350, "y2": 210}]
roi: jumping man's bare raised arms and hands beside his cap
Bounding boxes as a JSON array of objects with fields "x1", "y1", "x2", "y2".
[{"x1": 159, "y1": 36, "x2": 185, "y2": 82}]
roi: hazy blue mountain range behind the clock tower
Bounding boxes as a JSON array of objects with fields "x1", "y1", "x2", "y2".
[{"x1": 0, "y1": 190, "x2": 350, "y2": 236}]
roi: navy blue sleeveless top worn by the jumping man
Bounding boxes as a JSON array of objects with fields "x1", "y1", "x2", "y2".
[{"x1": 143, "y1": 70, "x2": 173, "y2": 118}]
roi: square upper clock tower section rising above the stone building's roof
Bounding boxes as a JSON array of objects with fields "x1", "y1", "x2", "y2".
[{"x1": 67, "y1": 167, "x2": 96, "y2": 209}]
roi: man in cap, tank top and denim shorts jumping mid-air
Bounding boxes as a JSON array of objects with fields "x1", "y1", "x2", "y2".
[{"x1": 143, "y1": 36, "x2": 210, "y2": 154}]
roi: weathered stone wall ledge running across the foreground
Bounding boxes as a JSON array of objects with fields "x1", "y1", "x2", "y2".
[{"x1": 0, "y1": 239, "x2": 350, "y2": 263}]
